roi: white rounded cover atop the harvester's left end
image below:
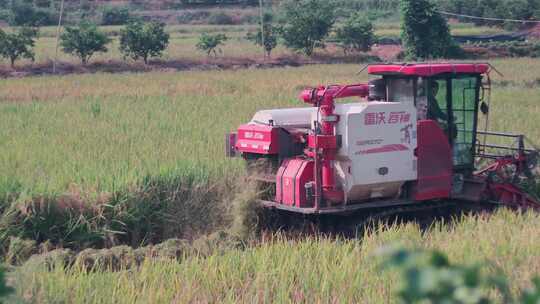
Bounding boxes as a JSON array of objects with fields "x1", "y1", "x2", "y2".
[{"x1": 251, "y1": 107, "x2": 317, "y2": 128}]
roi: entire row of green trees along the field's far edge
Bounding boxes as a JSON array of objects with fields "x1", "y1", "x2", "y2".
[{"x1": 0, "y1": 0, "x2": 476, "y2": 66}]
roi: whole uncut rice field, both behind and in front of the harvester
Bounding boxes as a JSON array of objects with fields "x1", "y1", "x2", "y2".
[{"x1": 0, "y1": 58, "x2": 540, "y2": 303}]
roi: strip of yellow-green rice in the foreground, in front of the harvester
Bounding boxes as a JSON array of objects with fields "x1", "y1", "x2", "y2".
[{"x1": 9, "y1": 211, "x2": 540, "y2": 303}]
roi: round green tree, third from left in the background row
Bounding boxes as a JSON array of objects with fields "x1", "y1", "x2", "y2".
[{"x1": 120, "y1": 20, "x2": 170, "y2": 64}]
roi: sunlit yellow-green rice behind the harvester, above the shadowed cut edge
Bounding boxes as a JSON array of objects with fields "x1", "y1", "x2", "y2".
[{"x1": 0, "y1": 59, "x2": 540, "y2": 195}]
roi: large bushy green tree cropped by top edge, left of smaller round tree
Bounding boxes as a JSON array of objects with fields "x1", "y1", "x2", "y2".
[{"x1": 280, "y1": 0, "x2": 336, "y2": 56}]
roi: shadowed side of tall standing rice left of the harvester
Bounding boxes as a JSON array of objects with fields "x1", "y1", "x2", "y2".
[{"x1": 0, "y1": 175, "x2": 233, "y2": 263}]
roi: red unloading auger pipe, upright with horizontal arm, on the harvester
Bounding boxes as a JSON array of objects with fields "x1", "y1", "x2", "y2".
[{"x1": 300, "y1": 84, "x2": 369, "y2": 209}]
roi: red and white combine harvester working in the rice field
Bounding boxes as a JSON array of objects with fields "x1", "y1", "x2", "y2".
[{"x1": 226, "y1": 63, "x2": 540, "y2": 214}]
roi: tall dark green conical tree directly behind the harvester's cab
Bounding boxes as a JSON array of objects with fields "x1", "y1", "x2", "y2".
[{"x1": 401, "y1": 0, "x2": 459, "y2": 60}]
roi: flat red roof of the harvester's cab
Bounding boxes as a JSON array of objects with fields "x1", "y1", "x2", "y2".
[{"x1": 368, "y1": 63, "x2": 489, "y2": 77}]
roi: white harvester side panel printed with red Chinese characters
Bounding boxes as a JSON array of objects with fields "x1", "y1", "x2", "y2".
[{"x1": 335, "y1": 102, "x2": 417, "y2": 201}]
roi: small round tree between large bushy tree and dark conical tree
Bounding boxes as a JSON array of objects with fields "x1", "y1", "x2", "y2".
[{"x1": 336, "y1": 13, "x2": 376, "y2": 53}]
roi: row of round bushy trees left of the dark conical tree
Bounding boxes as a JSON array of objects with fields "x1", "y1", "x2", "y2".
[{"x1": 0, "y1": 0, "x2": 376, "y2": 66}]
